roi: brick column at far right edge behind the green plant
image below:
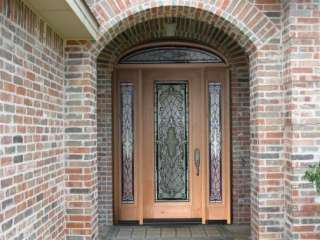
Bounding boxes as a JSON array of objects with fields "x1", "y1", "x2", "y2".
[{"x1": 282, "y1": 0, "x2": 320, "y2": 239}]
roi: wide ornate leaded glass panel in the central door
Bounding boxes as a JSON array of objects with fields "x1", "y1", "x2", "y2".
[{"x1": 155, "y1": 81, "x2": 188, "y2": 201}]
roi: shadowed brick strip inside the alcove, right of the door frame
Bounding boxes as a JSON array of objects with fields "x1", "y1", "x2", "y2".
[{"x1": 230, "y1": 50, "x2": 250, "y2": 223}]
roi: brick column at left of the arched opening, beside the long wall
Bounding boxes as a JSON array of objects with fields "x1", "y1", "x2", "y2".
[{"x1": 65, "y1": 41, "x2": 98, "y2": 240}]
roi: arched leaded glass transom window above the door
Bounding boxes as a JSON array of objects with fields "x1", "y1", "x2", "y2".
[{"x1": 120, "y1": 46, "x2": 224, "y2": 64}]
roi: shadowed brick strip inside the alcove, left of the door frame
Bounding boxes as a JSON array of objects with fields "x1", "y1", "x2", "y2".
[{"x1": 97, "y1": 53, "x2": 113, "y2": 235}]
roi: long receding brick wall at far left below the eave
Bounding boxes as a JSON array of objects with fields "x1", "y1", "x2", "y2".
[{"x1": 0, "y1": 1, "x2": 64, "y2": 239}]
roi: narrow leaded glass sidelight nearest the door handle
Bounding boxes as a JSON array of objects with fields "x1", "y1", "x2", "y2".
[{"x1": 209, "y1": 82, "x2": 222, "y2": 202}]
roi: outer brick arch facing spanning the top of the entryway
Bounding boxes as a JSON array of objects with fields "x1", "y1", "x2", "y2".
[{"x1": 91, "y1": 0, "x2": 279, "y2": 56}]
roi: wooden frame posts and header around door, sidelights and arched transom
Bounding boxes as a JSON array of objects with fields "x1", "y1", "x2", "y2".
[{"x1": 112, "y1": 42, "x2": 232, "y2": 224}]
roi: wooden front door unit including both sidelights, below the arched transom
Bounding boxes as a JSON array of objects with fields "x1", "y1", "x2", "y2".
[{"x1": 113, "y1": 65, "x2": 230, "y2": 223}]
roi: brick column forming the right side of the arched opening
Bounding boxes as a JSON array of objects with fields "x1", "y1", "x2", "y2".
[{"x1": 250, "y1": 38, "x2": 284, "y2": 240}]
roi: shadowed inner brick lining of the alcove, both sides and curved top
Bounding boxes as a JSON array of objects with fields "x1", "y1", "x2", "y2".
[{"x1": 97, "y1": 17, "x2": 250, "y2": 229}]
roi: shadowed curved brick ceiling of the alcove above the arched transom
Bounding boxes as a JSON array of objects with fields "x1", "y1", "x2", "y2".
[{"x1": 99, "y1": 17, "x2": 246, "y2": 66}]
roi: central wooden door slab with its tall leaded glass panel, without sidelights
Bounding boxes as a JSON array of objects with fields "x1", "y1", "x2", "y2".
[{"x1": 143, "y1": 69, "x2": 205, "y2": 219}]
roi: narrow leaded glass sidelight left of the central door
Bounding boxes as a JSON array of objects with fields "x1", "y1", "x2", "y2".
[{"x1": 120, "y1": 83, "x2": 134, "y2": 203}]
